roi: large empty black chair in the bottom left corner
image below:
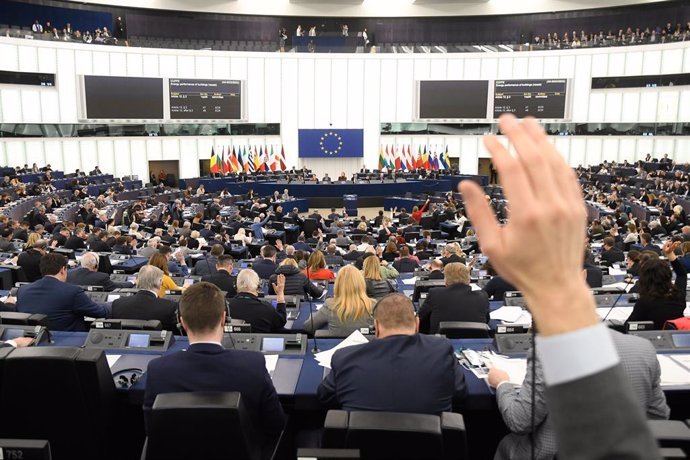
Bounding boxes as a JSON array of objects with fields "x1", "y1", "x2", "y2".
[{"x1": 0, "y1": 347, "x2": 115, "y2": 460}]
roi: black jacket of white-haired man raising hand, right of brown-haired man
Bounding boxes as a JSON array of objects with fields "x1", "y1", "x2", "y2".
[{"x1": 228, "y1": 292, "x2": 287, "y2": 333}]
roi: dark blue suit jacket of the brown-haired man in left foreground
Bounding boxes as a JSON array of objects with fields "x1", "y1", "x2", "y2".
[{"x1": 144, "y1": 343, "x2": 285, "y2": 438}]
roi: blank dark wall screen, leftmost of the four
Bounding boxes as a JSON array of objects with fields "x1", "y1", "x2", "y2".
[{"x1": 84, "y1": 75, "x2": 163, "y2": 120}]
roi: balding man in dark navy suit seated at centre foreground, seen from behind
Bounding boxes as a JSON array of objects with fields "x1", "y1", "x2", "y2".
[{"x1": 318, "y1": 293, "x2": 467, "y2": 414}]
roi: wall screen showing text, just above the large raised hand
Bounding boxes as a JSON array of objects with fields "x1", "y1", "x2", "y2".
[{"x1": 494, "y1": 79, "x2": 568, "y2": 118}]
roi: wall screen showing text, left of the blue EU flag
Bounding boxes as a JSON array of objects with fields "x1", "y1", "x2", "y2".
[{"x1": 168, "y1": 78, "x2": 242, "y2": 120}]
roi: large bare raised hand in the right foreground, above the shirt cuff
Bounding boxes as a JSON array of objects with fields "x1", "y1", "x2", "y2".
[{"x1": 460, "y1": 115, "x2": 599, "y2": 335}]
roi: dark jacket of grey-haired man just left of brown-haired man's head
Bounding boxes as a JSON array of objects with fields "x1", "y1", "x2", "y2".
[{"x1": 113, "y1": 291, "x2": 178, "y2": 332}]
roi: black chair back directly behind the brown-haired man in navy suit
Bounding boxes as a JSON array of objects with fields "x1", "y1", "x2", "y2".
[{"x1": 141, "y1": 392, "x2": 277, "y2": 460}]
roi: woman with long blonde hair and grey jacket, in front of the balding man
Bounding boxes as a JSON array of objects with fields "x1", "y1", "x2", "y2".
[{"x1": 304, "y1": 265, "x2": 376, "y2": 336}]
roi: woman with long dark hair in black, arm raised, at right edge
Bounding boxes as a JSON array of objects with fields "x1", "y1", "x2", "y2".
[{"x1": 628, "y1": 241, "x2": 688, "y2": 329}]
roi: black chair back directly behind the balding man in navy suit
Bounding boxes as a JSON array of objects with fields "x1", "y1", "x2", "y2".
[{"x1": 322, "y1": 410, "x2": 467, "y2": 460}]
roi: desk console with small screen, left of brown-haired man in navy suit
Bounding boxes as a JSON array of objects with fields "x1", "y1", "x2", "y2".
[{"x1": 84, "y1": 329, "x2": 175, "y2": 352}]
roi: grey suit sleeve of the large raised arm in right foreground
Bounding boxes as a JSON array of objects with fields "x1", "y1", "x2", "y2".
[{"x1": 546, "y1": 364, "x2": 661, "y2": 460}]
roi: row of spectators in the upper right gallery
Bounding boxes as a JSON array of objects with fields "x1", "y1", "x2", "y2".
[{"x1": 533, "y1": 22, "x2": 690, "y2": 49}]
